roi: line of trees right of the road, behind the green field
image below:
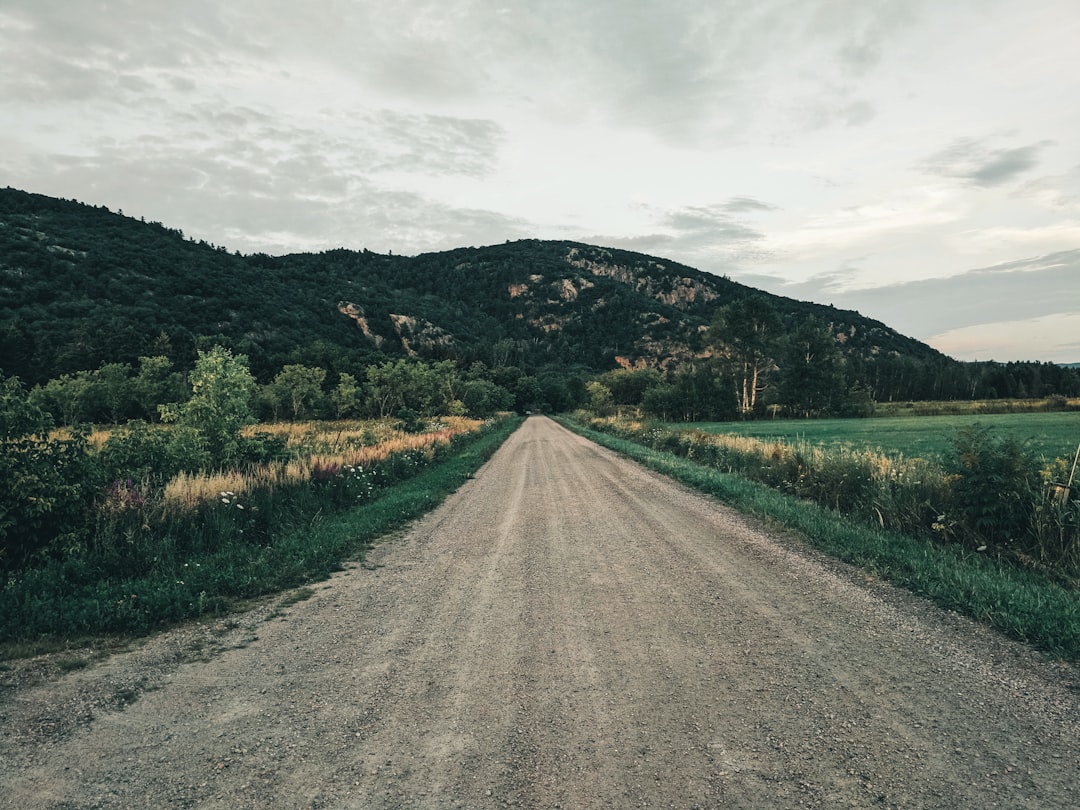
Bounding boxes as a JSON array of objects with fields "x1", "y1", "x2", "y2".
[{"x1": 589, "y1": 298, "x2": 1080, "y2": 421}]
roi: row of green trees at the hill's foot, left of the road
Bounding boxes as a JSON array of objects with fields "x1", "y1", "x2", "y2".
[{"x1": 12, "y1": 346, "x2": 586, "y2": 426}]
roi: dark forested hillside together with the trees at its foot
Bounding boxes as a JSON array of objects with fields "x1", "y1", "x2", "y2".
[{"x1": 6, "y1": 188, "x2": 1080, "y2": 424}]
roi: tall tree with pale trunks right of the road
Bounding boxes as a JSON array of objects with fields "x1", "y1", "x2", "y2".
[{"x1": 707, "y1": 297, "x2": 781, "y2": 415}]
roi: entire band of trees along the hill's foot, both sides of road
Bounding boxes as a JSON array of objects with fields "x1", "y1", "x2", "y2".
[{"x1": 14, "y1": 298, "x2": 1080, "y2": 434}]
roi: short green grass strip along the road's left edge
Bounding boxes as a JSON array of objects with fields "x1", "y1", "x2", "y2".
[{"x1": 0, "y1": 418, "x2": 522, "y2": 658}]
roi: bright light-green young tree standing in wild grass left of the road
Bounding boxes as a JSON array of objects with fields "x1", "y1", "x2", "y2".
[{"x1": 161, "y1": 346, "x2": 255, "y2": 464}]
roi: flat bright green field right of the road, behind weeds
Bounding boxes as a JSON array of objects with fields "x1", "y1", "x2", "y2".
[{"x1": 682, "y1": 411, "x2": 1080, "y2": 460}]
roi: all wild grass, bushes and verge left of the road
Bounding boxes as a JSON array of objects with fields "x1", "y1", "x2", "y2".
[{"x1": 0, "y1": 350, "x2": 518, "y2": 643}]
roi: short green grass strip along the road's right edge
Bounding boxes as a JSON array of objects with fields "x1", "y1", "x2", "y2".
[{"x1": 559, "y1": 419, "x2": 1080, "y2": 661}]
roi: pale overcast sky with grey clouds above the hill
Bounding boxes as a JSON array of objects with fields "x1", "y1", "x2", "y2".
[{"x1": 0, "y1": 0, "x2": 1080, "y2": 363}]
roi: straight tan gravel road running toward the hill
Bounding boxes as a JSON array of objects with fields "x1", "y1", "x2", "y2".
[{"x1": 0, "y1": 417, "x2": 1080, "y2": 810}]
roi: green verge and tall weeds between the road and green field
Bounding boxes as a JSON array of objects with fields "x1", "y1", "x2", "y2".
[{"x1": 567, "y1": 413, "x2": 1080, "y2": 660}]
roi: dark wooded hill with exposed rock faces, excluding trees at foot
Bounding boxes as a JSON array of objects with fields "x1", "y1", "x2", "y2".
[{"x1": 0, "y1": 188, "x2": 1075, "y2": 400}]
